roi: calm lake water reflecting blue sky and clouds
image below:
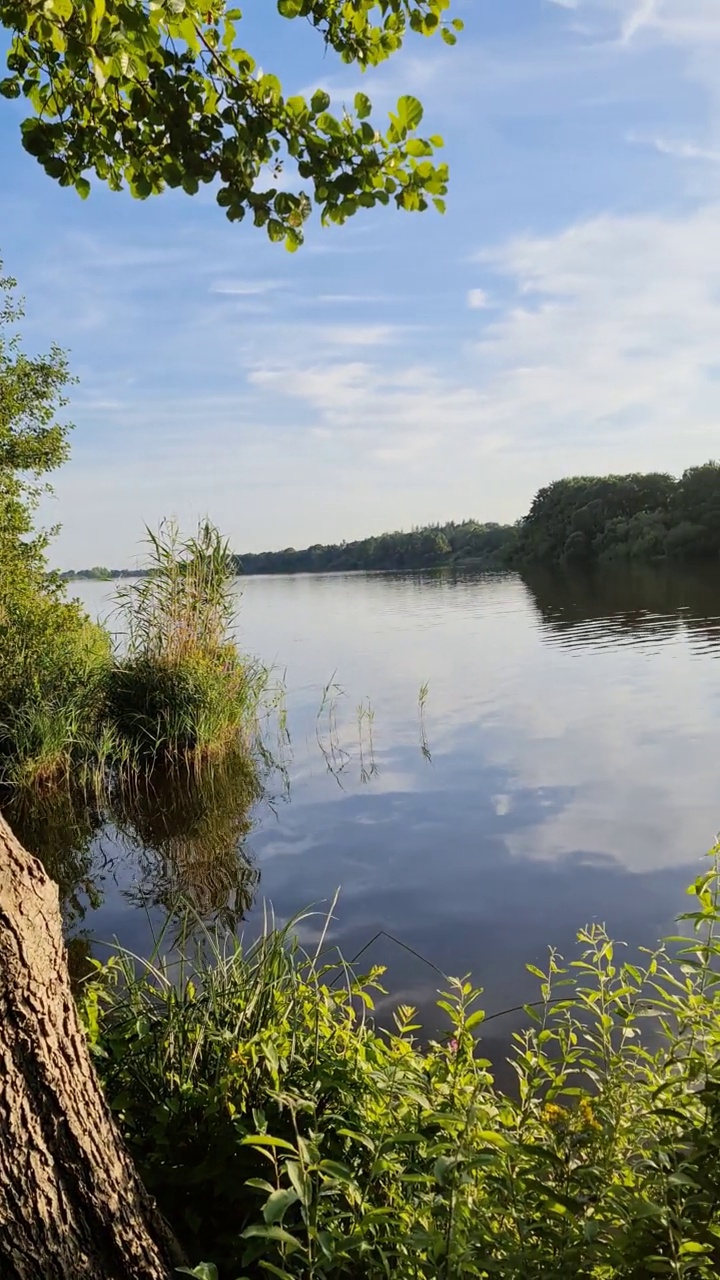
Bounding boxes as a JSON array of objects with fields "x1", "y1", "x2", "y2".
[{"x1": 19, "y1": 568, "x2": 720, "y2": 1055}]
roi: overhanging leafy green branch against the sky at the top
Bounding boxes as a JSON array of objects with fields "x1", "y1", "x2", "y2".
[{"x1": 0, "y1": 0, "x2": 462, "y2": 250}]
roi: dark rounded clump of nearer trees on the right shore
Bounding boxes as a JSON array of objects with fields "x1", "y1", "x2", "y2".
[{"x1": 510, "y1": 462, "x2": 720, "y2": 566}]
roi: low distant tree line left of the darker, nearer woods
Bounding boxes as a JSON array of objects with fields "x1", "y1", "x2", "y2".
[{"x1": 236, "y1": 520, "x2": 515, "y2": 573}]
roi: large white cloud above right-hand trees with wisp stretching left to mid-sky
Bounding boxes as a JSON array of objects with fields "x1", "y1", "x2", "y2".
[{"x1": 243, "y1": 206, "x2": 720, "y2": 483}]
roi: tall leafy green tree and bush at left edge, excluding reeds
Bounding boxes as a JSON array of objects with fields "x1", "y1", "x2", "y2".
[{"x1": 0, "y1": 267, "x2": 110, "y2": 782}]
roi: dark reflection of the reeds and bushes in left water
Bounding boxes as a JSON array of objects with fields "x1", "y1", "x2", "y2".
[{"x1": 1, "y1": 754, "x2": 263, "y2": 947}]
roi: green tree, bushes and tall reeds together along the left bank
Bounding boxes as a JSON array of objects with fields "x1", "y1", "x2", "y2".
[{"x1": 0, "y1": 270, "x2": 265, "y2": 787}]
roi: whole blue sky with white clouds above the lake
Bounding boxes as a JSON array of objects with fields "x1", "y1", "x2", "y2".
[{"x1": 0, "y1": 0, "x2": 720, "y2": 567}]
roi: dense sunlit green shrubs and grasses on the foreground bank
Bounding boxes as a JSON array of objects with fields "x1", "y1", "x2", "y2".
[{"x1": 85, "y1": 850, "x2": 720, "y2": 1280}]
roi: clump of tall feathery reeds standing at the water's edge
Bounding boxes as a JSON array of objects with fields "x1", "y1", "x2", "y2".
[{"x1": 109, "y1": 521, "x2": 264, "y2": 762}]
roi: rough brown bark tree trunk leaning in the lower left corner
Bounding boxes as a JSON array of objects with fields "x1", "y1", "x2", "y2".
[{"x1": 0, "y1": 817, "x2": 183, "y2": 1280}]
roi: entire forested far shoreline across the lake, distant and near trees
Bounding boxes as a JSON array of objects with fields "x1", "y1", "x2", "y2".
[{"x1": 61, "y1": 462, "x2": 720, "y2": 581}]
